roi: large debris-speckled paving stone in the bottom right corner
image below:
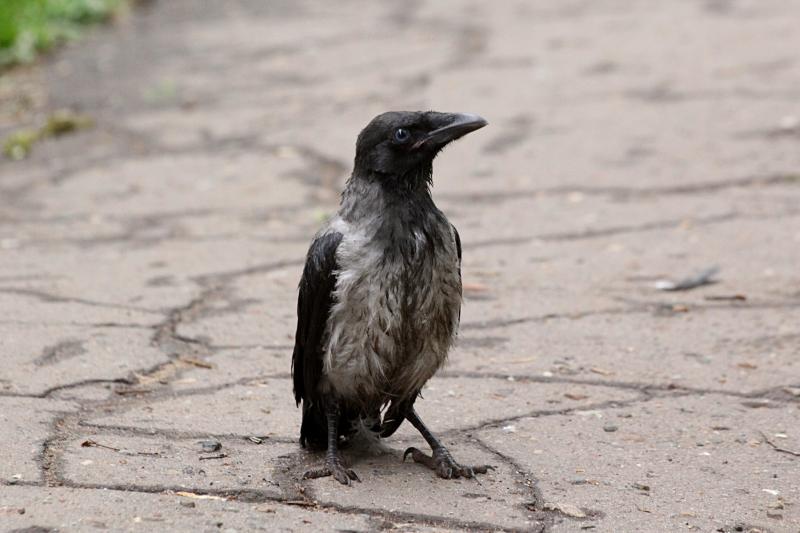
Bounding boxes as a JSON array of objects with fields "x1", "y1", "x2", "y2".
[{"x1": 479, "y1": 395, "x2": 800, "y2": 531}]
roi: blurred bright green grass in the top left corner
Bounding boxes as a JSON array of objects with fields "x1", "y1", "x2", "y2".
[{"x1": 0, "y1": 0, "x2": 125, "y2": 68}]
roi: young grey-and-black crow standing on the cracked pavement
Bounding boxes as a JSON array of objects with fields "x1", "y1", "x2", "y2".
[{"x1": 292, "y1": 111, "x2": 491, "y2": 485}]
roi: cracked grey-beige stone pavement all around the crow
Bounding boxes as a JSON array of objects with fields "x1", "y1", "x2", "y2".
[{"x1": 0, "y1": 0, "x2": 800, "y2": 532}]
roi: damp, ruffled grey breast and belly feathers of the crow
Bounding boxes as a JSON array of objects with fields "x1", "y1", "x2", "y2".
[{"x1": 325, "y1": 221, "x2": 461, "y2": 403}]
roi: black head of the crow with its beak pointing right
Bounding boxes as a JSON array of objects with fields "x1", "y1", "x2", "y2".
[{"x1": 354, "y1": 111, "x2": 487, "y2": 186}]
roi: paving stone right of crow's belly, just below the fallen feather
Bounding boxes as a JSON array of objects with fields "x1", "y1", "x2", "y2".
[{"x1": 449, "y1": 303, "x2": 800, "y2": 393}]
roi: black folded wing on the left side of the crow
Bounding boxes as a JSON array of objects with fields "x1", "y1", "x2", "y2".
[{"x1": 292, "y1": 232, "x2": 342, "y2": 404}]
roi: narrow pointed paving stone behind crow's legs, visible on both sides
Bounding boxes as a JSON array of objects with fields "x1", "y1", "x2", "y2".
[{"x1": 90, "y1": 370, "x2": 638, "y2": 440}]
